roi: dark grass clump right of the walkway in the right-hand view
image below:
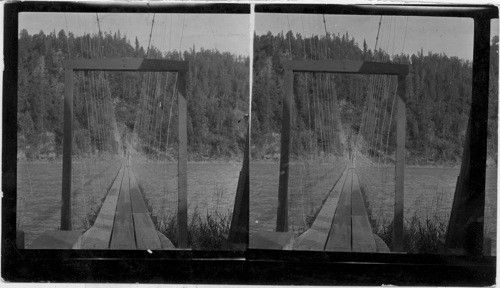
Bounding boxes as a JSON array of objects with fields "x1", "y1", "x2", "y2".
[{"x1": 373, "y1": 214, "x2": 447, "y2": 254}]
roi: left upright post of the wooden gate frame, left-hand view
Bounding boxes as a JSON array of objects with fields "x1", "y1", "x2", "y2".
[{"x1": 61, "y1": 68, "x2": 73, "y2": 230}]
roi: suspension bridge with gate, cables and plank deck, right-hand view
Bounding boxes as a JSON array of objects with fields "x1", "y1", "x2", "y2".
[{"x1": 250, "y1": 15, "x2": 409, "y2": 252}]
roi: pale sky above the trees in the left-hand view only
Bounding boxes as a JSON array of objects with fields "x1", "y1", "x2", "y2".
[{"x1": 19, "y1": 12, "x2": 250, "y2": 56}]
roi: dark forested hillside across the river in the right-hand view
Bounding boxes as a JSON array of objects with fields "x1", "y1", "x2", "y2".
[{"x1": 252, "y1": 32, "x2": 498, "y2": 164}]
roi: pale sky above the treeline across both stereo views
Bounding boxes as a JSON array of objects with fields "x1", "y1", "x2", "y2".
[{"x1": 19, "y1": 12, "x2": 498, "y2": 60}]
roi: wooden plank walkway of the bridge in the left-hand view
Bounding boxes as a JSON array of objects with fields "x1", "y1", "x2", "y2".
[{"x1": 81, "y1": 163, "x2": 174, "y2": 250}]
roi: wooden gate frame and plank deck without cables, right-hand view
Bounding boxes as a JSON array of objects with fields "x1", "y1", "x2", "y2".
[{"x1": 250, "y1": 60, "x2": 409, "y2": 252}]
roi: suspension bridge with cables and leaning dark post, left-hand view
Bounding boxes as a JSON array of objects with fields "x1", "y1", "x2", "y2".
[{"x1": 18, "y1": 14, "x2": 249, "y2": 250}]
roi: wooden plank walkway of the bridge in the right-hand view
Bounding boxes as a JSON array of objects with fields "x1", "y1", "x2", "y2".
[{"x1": 293, "y1": 165, "x2": 388, "y2": 252}]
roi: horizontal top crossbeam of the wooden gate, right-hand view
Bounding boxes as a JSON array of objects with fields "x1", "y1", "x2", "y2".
[{"x1": 283, "y1": 60, "x2": 410, "y2": 75}]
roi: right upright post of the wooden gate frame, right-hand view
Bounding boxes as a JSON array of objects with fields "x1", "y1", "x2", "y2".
[{"x1": 392, "y1": 75, "x2": 406, "y2": 252}]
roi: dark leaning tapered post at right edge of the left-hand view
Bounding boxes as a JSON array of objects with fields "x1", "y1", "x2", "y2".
[{"x1": 227, "y1": 117, "x2": 250, "y2": 244}]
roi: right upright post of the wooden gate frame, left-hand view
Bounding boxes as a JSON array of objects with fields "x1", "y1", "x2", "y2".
[{"x1": 177, "y1": 71, "x2": 188, "y2": 248}]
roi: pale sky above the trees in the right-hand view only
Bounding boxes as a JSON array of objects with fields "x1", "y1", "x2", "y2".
[{"x1": 255, "y1": 13, "x2": 498, "y2": 60}]
